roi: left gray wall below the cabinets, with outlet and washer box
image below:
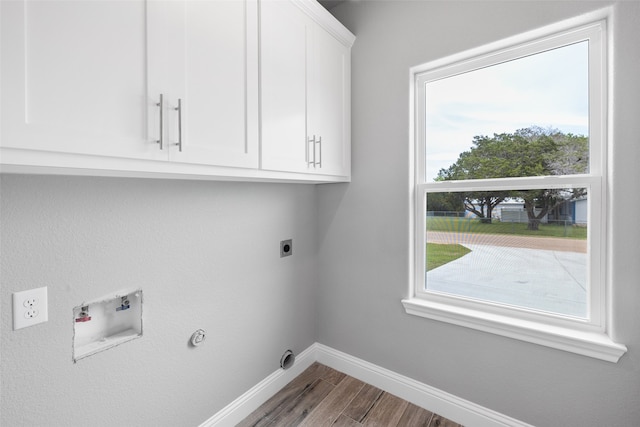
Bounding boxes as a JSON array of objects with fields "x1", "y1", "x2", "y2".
[{"x1": 0, "y1": 175, "x2": 317, "y2": 427}]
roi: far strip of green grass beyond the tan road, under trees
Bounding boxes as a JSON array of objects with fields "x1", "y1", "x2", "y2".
[{"x1": 427, "y1": 217, "x2": 587, "y2": 239}]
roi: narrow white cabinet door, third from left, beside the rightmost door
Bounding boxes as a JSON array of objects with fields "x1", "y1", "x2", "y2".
[{"x1": 260, "y1": 1, "x2": 309, "y2": 172}]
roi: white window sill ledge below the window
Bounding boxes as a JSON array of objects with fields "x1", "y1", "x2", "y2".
[{"x1": 402, "y1": 298, "x2": 627, "y2": 363}]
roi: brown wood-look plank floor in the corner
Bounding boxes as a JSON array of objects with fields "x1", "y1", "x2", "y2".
[{"x1": 237, "y1": 363, "x2": 462, "y2": 427}]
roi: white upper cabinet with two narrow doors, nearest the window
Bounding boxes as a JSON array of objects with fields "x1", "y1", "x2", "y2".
[{"x1": 260, "y1": 0, "x2": 353, "y2": 177}]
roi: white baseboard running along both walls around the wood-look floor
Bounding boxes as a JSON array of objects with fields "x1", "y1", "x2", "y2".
[{"x1": 200, "y1": 343, "x2": 532, "y2": 427}]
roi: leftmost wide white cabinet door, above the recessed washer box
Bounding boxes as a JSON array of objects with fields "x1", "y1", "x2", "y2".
[{"x1": 0, "y1": 0, "x2": 161, "y2": 162}]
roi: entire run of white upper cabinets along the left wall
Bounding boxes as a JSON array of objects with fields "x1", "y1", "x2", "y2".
[{"x1": 0, "y1": 0, "x2": 353, "y2": 182}]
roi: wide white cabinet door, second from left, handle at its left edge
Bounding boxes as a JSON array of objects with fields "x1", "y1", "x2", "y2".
[{"x1": 165, "y1": 0, "x2": 258, "y2": 168}]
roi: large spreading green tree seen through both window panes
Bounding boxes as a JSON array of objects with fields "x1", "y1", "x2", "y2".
[{"x1": 436, "y1": 126, "x2": 589, "y2": 230}]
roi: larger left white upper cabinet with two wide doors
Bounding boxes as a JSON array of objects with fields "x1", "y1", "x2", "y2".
[{"x1": 2, "y1": 0, "x2": 258, "y2": 168}]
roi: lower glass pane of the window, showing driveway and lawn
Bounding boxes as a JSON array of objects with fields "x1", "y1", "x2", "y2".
[{"x1": 425, "y1": 188, "x2": 588, "y2": 318}]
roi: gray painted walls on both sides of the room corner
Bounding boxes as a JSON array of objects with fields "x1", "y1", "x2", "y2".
[{"x1": 0, "y1": 1, "x2": 640, "y2": 427}]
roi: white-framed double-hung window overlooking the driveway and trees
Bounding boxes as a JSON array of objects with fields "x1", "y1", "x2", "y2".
[{"x1": 404, "y1": 17, "x2": 615, "y2": 364}]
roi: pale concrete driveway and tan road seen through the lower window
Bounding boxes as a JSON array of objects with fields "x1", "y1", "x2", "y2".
[{"x1": 427, "y1": 232, "x2": 587, "y2": 317}]
